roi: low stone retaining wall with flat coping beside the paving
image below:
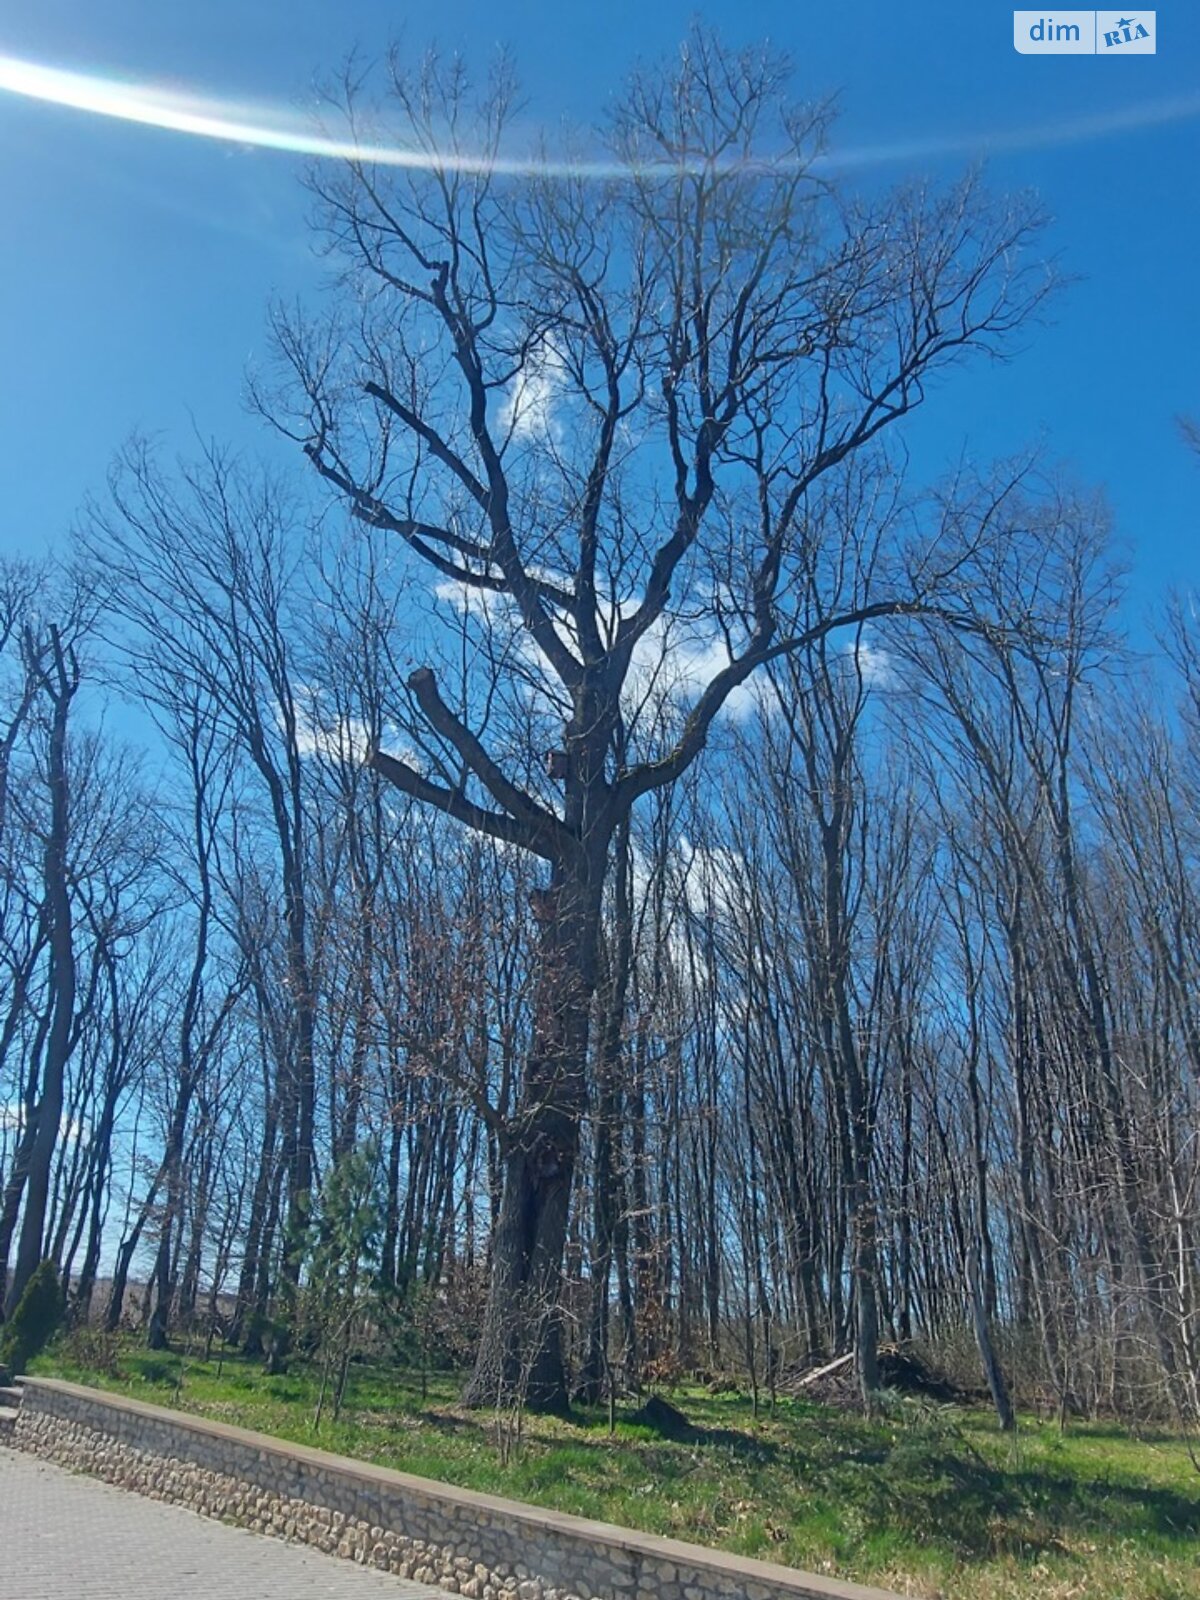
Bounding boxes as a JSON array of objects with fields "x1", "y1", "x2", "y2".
[{"x1": 11, "y1": 1378, "x2": 894, "y2": 1600}]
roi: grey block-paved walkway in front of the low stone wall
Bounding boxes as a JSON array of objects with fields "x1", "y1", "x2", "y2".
[{"x1": 0, "y1": 1446, "x2": 450, "y2": 1600}]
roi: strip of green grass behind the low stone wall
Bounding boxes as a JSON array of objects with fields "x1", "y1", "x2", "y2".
[{"x1": 34, "y1": 1344, "x2": 1200, "y2": 1600}]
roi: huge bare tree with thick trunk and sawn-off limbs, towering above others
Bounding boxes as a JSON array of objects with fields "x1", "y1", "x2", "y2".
[{"x1": 264, "y1": 32, "x2": 1048, "y2": 1406}]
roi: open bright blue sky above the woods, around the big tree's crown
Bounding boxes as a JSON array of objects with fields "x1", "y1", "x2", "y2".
[{"x1": 0, "y1": 0, "x2": 1200, "y2": 610}]
